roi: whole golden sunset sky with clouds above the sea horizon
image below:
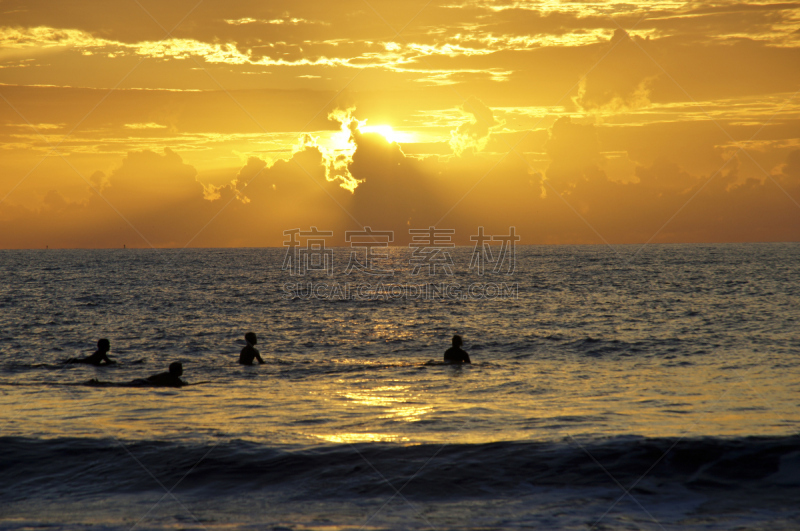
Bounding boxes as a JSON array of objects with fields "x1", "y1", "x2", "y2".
[{"x1": 0, "y1": 0, "x2": 800, "y2": 248}]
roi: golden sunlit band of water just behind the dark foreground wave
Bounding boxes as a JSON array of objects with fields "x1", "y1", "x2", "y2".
[{"x1": 0, "y1": 353, "x2": 797, "y2": 444}]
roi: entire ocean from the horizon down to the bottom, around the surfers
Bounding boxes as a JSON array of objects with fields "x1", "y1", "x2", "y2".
[{"x1": 0, "y1": 243, "x2": 800, "y2": 530}]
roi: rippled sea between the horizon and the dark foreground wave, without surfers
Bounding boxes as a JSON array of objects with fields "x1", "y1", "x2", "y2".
[{"x1": 0, "y1": 244, "x2": 800, "y2": 528}]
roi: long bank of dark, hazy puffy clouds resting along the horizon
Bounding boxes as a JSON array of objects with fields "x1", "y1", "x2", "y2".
[{"x1": 0, "y1": 119, "x2": 800, "y2": 247}]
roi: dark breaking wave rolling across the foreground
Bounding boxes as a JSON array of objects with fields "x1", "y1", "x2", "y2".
[{"x1": 0, "y1": 435, "x2": 800, "y2": 501}]
